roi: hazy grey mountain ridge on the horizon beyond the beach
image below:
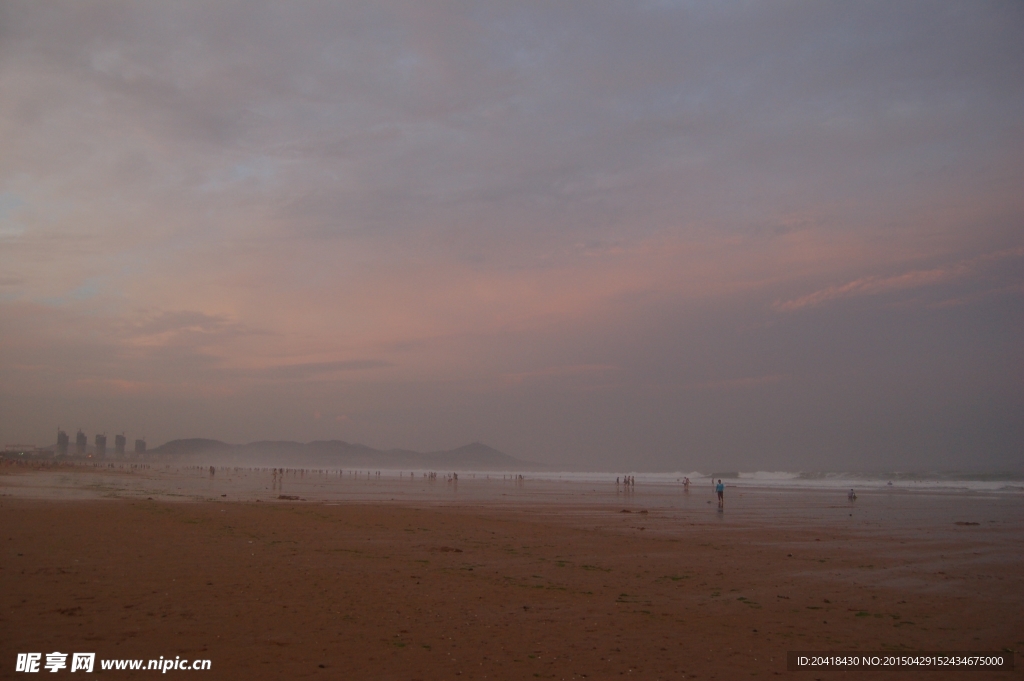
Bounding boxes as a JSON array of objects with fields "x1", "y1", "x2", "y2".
[{"x1": 146, "y1": 437, "x2": 544, "y2": 471}]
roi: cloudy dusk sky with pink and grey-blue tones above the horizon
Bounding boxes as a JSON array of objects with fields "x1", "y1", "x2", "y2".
[{"x1": 0, "y1": 0, "x2": 1024, "y2": 471}]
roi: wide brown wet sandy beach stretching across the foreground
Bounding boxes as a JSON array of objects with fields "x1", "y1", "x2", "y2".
[{"x1": 0, "y1": 470, "x2": 1024, "y2": 680}]
